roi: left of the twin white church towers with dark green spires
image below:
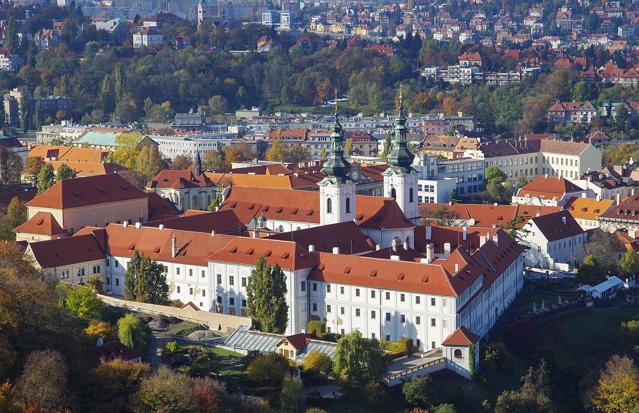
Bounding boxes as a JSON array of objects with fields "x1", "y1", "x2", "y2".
[{"x1": 318, "y1": 108, "x2": 355, "y2": 225}]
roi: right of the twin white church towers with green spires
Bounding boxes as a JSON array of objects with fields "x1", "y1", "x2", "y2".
[{"x1": 382, "y1": 89, "x2": 419, "y2": 220}]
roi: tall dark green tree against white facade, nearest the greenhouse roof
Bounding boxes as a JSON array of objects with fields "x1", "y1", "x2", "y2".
[{"x1": 246, "y1": 257, "x2": 288, "y2": 334}]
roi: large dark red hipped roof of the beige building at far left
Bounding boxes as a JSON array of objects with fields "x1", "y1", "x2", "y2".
[{"x1": 27, "y1": 174, "x2": 147, "y2": 209}]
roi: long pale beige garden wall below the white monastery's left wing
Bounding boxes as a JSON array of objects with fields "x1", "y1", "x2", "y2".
[{"x1": 98, "y1": 294, "x2": 251, "y2": 331}]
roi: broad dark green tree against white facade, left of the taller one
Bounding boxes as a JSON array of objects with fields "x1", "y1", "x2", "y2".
[{"x1": 124, "y1": 251, "x2": 169, "y2": 304}]
